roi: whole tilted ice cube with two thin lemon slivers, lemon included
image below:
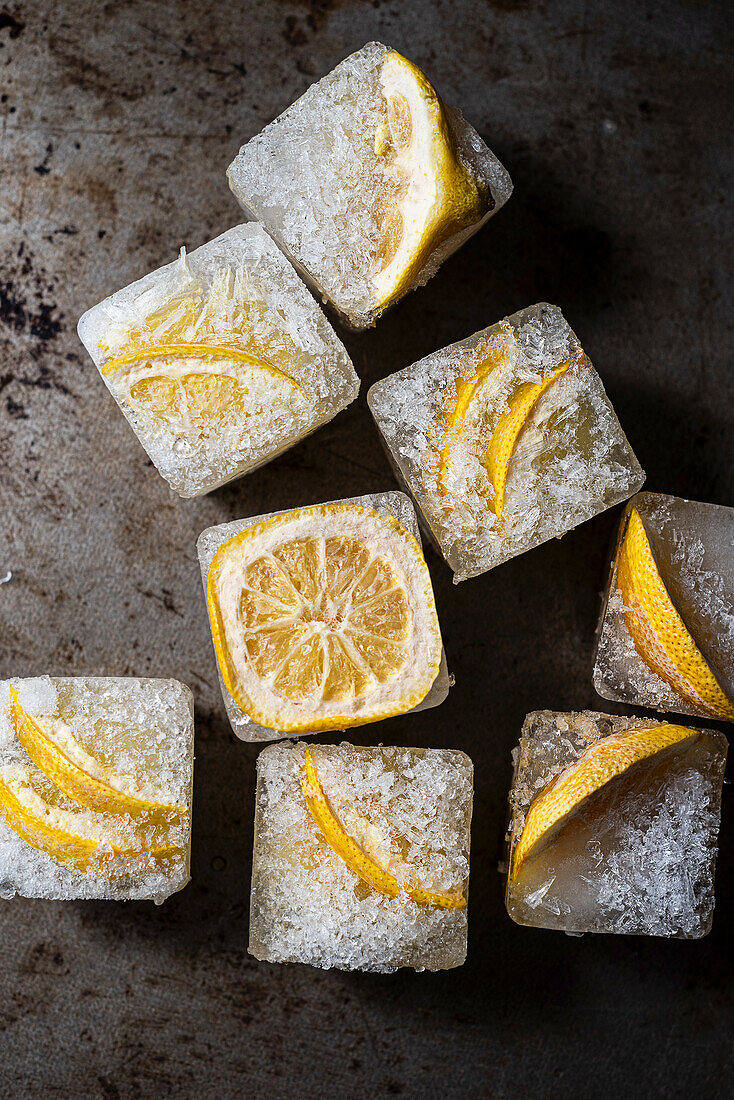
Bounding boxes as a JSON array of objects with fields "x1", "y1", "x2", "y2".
[{"x1": 368, "y1": 304, "x2": 645, "y2": 583}]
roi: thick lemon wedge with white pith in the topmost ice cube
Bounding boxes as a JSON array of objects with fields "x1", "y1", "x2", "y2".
[{"x1": 373, "y1": 52, "x2": 494, "y2": 308}]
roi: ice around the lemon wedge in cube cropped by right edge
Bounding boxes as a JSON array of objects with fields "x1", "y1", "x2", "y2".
[{"x1": 594, "y1": 493, "x2": 734, "y2": 718}]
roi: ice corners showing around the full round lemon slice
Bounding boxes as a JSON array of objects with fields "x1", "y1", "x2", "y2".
[{"x1": 196, "y1": 493, "x2": 452, "y2": 741}]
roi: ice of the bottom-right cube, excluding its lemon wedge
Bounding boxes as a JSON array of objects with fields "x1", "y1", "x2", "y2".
[{"x1": 506, "y1": 711, "x2": 728, "y2": 939}]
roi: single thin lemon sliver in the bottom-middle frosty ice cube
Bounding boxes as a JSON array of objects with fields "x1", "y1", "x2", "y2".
[{"x1": 300, "y1": 749, "x2": 467, "y2": 909}]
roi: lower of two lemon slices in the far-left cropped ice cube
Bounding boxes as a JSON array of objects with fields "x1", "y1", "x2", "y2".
[{"x1": 0, "y1": 773, "x2": 182, "y2": 876}]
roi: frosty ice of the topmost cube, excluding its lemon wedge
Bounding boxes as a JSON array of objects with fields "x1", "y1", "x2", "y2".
[{"x1": 228, "y1": 42, "x2": 512, "y2": 328}]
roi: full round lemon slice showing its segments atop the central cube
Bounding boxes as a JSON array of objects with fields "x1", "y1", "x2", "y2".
[{"x1": 207, "y1": 504, "x2": 441, "y2": 733}]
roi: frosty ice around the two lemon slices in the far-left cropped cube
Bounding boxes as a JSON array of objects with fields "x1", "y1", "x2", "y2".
[{"x1": 0, "y1": 677, "x2": 194, "y2": 903}]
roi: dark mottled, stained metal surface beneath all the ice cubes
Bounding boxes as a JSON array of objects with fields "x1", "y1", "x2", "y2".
[{"x1": 0, "y1": 0, "x2": 734, "y2": 1100}]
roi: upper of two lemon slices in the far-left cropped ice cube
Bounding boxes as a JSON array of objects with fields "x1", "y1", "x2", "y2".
[{"x1": 10, "y1": 686, "x2": 187, "y2": 826}]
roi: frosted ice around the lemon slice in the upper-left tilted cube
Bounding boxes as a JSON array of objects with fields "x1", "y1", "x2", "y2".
[{"x1": 78, "y1": 224, "x2": 359, "y2": 497}]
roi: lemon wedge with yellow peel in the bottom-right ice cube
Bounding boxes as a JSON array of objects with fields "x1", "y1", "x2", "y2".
[{"x1": 512, "y1": 725, "x2": 699, "y2": 878}]
